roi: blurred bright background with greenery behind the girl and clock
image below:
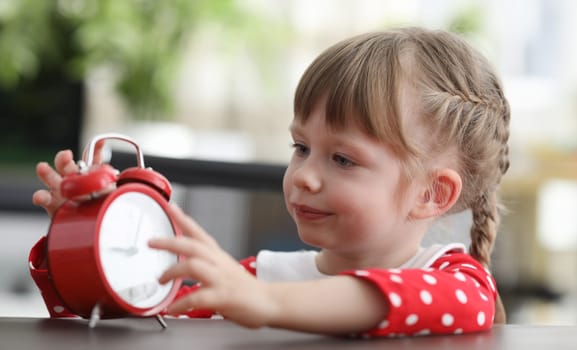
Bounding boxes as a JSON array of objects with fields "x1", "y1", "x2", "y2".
[{"x1": 0, "y1": 0, "x2": 577, "y2": 324}]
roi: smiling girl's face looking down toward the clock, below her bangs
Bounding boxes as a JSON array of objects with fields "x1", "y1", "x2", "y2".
[{"x1": 283, "y1": 104, "x2": 420, "y2": 264}]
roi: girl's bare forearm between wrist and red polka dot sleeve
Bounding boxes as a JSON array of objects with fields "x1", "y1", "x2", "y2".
[{"x1": 268, "y1": 276, "x2": 388, "y2": 334}]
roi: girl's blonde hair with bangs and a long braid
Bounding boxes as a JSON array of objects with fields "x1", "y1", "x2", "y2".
[{"x1": 294, "y1": 28, "x2": 510, "y2": 320}]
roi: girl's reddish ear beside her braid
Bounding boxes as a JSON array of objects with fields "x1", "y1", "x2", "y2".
[{"x1": 410, "y1": 168, "x2": 463, "y2": 219}]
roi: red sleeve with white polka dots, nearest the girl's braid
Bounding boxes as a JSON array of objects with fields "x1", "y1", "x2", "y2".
[{"x1": 343, "y1": 253, "x2": 497, "y2": 337}]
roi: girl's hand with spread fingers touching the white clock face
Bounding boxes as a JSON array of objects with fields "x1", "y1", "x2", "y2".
[{"x1": 149, "y1": 205, "x2": 276, "y2": 328}]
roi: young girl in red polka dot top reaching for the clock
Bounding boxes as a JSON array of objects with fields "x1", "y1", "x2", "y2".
[{"x1": 33, "y1": 28, "x2": 509, "y2": 336}]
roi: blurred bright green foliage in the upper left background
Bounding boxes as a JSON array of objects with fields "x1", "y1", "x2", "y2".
[{"x1": 0, "y1": 0, "x2": 282, "y2": 119}]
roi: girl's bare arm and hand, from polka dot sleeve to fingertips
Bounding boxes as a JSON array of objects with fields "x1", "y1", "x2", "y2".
[{"x1": 149, "y1": 207, "x2": 387, "y2": 334}]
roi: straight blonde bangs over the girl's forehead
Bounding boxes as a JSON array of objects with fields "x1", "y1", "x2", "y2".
[{"x1": 294, "y1": 33, "x2": 412, "y2": 158}]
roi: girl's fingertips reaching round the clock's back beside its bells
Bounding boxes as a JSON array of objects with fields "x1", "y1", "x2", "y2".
[{"x1": 32, "y1": 142, "x2": 104, "y2": 217}]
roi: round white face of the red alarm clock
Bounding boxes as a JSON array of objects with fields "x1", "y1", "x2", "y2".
[{"x1": 98, "y1": 192, "x2": 178, "y2": 308}]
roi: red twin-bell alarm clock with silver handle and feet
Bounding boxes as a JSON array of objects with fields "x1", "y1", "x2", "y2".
[{"x1": 46, "y1": 134, "x2": 180, "y2": 327}]
